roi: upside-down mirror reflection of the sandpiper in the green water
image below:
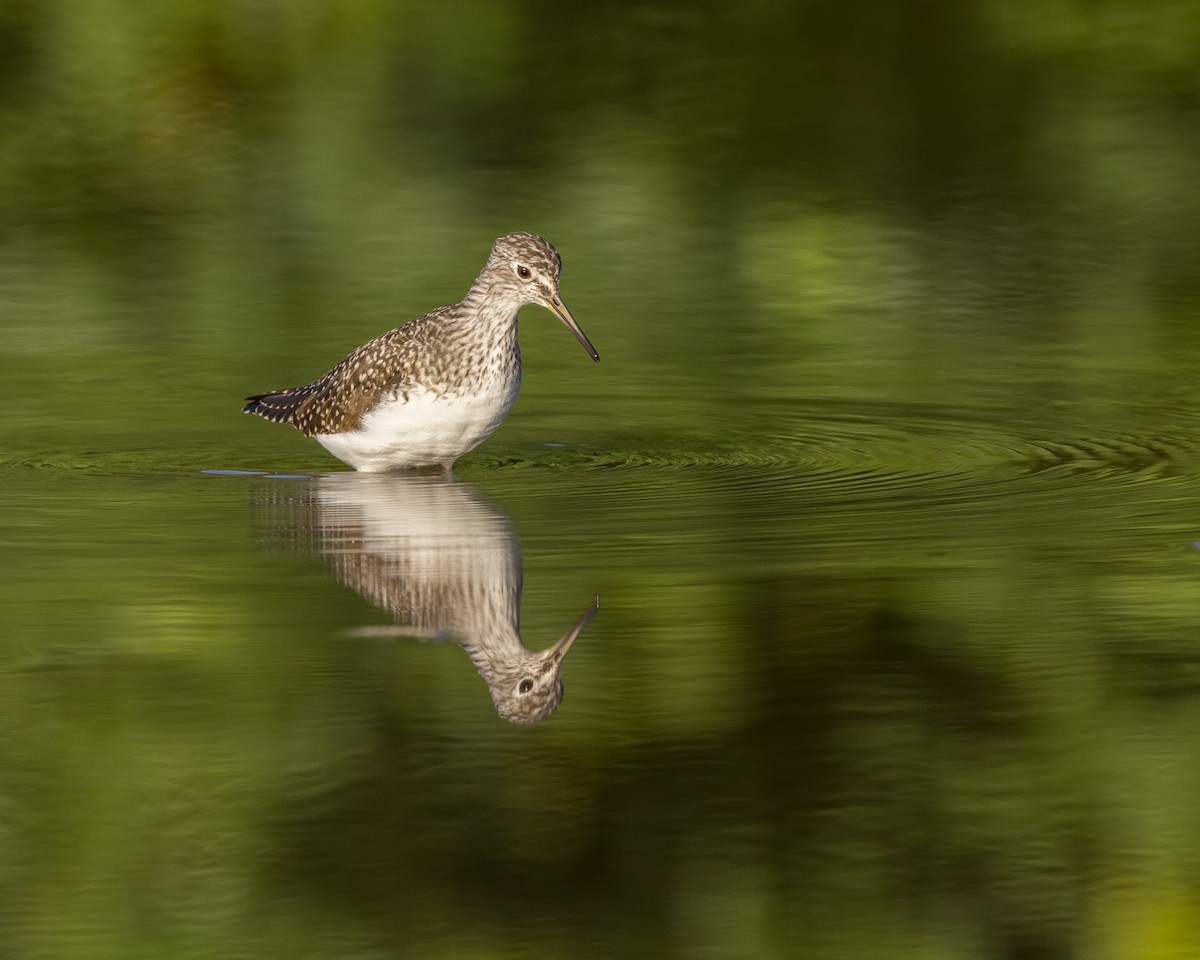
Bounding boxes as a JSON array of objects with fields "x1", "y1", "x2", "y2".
[{"x1": 266, "y1": 473, "x2": 599, "y2": 724}]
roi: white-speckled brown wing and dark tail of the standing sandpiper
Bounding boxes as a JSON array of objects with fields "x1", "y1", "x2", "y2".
[{"x1": 242, "y1": 307, "x2": 451, "y2": 437}]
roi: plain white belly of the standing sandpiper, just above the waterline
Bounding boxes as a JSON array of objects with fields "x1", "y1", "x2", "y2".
[{"x1": 313, "y1": 385, "x2": 517, "y2": 473}]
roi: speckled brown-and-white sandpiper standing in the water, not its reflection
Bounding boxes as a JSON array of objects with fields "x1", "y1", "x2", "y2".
[{"x1": 242, "y1": 232, "x2": 600, "y2": 473}]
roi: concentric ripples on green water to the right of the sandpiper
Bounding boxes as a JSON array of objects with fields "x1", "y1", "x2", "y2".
[{"x1": 472, "y1": 403, "x2": 1200, "y2": 520}]
